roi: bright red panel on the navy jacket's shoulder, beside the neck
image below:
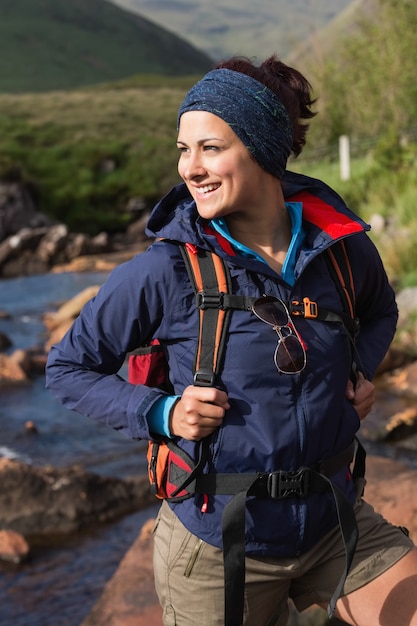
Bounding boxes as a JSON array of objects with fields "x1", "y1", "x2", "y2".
[{"x1": 286, "y1": 191, "x2": 363, "y2": 239}]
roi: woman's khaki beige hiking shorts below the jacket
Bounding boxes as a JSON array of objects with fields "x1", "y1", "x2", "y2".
[{"x1": 154, "y1": 499, "x2": 413, "y2": 626}]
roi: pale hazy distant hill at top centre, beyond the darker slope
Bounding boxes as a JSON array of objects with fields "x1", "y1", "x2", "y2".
[{"x1": 112, "y1": 0, "x2": 352, "y2": 59}]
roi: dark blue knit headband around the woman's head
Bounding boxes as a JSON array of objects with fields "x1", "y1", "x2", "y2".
[{"x1": 178, "y1": 68, "x2": 293, "y2": 178}]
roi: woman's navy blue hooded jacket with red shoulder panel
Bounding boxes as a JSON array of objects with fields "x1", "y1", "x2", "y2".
[{"x1": 47, "y1": 172, "x2": 397, "y2": 556}]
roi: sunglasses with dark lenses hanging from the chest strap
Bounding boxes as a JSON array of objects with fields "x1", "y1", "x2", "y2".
[{"x1": 252, "y1": 296, "x2": 306, "y2": 374}]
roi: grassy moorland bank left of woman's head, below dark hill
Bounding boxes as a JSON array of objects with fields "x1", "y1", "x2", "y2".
[{"x1": 0, "y1": 76, "x2": 197, "y2": 234}]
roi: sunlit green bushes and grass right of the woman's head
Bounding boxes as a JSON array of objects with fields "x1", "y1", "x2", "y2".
[{"x1": 288, "y1": 0, "x2": 417, "y2": 286}]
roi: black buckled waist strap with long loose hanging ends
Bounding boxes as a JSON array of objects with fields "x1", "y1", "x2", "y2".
[{"x1": 195, "y1": 442, "x2": 365, "y2": 626}]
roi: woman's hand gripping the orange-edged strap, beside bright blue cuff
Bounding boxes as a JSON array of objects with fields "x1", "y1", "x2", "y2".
[{"x1": 169, "y1": 385, "x2": 230, "y2": 441}]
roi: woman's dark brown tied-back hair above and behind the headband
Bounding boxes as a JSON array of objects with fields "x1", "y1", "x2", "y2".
[{"x1": 215, "y1": 55, "x2": 316, "y2": 157}]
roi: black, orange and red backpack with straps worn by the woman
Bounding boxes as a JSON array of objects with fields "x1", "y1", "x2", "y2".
[{"x1": 128, "y1": 240, "x2": 365, "y2": 626}]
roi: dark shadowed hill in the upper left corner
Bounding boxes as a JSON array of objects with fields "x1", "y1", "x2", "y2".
[{"x1": 0, "y1": 0, "x2": 211, "y2": 93}]
